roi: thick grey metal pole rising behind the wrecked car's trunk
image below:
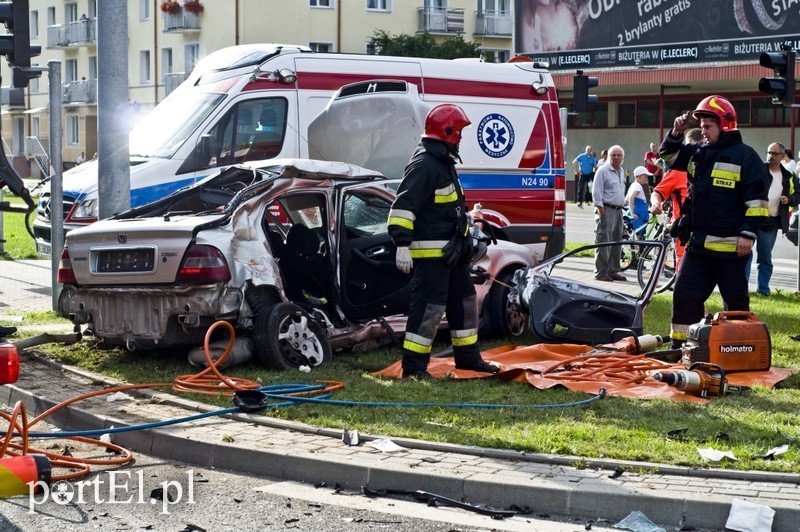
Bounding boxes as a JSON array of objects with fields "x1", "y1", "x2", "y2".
[{"x1": 97, "y1": 0, "x2": 131, "y2": 218}]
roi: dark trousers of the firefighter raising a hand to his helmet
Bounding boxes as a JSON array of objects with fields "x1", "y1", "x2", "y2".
[{"x1": 670, "y1": 249, "x2": 750, "y2": 345}]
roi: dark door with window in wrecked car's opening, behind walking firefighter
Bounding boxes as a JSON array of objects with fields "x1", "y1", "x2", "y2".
[{"x1": 339, "y1": 186, "x2": 411, "y2": 320}]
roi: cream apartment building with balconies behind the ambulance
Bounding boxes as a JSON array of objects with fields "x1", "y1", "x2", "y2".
[{"x1": 0, "y1": 0, "x2": 513, "y2": 176}]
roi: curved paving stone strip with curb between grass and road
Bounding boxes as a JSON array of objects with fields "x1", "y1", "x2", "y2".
[{"x1": 0, "y1": 355, "x2": 800, "y2": 532}]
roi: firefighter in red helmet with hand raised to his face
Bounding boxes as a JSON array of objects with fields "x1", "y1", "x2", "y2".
[{"x1": 660, "y1": 95, "x2": 767, "y2": 347}]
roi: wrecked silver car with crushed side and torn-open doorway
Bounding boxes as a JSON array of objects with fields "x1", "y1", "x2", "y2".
[{"x1": 58, "y1": 159, "x2": 534, "y2": 368}]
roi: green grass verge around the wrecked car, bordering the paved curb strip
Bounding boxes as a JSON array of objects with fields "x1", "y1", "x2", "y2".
[{"x1": 17, "y1": 291, "x2": 800, "y2": 473}]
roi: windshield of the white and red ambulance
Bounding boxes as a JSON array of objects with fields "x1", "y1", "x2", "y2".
[{"x1": 130, "y1": 91, "x2": 226, "y2": 159}]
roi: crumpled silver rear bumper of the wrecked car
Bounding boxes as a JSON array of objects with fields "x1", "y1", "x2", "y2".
[{"x1": 59, "y1": 284, "x2": 242, "y2": 344}]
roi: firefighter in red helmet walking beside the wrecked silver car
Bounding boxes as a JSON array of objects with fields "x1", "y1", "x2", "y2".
[{"x1": 388, "y1": 104, "x2": 498, "y2": 379}]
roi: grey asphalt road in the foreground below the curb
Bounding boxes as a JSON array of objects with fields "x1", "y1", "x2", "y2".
[{"x1": 0, "y1": 449, "x2": 624, "y2": 532}]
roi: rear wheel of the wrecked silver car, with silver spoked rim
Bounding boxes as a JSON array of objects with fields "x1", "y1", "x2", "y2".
[{"x1": 253, "y1": 303, "x2": 333, "y2": 370}]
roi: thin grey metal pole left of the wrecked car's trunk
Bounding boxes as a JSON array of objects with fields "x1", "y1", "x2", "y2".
[{"x1": 47, "y1": 60, "x2": 64, "y2": 311}]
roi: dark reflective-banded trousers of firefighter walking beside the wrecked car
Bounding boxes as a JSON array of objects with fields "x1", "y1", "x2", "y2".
[{"x1": 403, "y1": 260, "x2": 481, "y2": 372}]
